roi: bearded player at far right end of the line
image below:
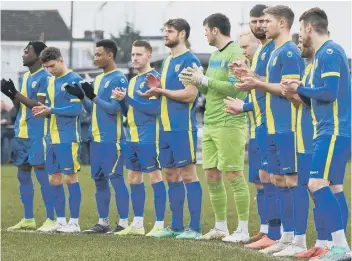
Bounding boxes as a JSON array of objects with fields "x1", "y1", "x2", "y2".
[{"x1": 282, "y1": 7, "x2": 351, "y2": 261}]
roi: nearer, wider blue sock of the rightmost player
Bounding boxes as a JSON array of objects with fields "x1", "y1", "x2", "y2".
[{"x1": 313, "y1": 187, "x2": 344, "y2": 233}]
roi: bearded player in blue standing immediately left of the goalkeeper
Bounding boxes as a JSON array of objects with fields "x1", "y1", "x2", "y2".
[{"x1": 141, "y1": 18, "x2": 202, "y2": 239}]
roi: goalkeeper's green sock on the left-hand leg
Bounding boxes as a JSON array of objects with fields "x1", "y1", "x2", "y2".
[{"x1": 207, "y1": 179, "x2": 227, "y2": 221}]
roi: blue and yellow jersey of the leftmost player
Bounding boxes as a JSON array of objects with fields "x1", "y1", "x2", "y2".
[{"x1": 15, "y1": 68, "x2": 50, "y2": 139}]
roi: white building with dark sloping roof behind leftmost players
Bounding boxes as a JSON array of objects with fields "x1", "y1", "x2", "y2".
[{"x1": 1, "y1": 10, "x2": 94, "y2": 86}]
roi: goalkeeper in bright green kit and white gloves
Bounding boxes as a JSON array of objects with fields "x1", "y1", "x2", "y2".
[{"x1": 179, "y1": 13, "x2": 249, "y2": 242}]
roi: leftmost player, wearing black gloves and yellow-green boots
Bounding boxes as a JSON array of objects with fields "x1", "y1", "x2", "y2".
[{"x1": 1, "y1": 41, "x2": 55, "y2": 232}]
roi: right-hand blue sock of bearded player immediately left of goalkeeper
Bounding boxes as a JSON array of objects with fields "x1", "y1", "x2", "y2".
[{"x1": 186, "y1": 181, "x2": 203, "y2": 232}]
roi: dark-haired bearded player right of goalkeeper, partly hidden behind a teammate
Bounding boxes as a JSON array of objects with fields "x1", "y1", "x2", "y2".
[{"x1": 225, "y1": 5, "x2": 281, "y2": 249}]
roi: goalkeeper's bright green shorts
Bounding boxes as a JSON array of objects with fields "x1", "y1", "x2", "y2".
[{"x1": 202, "y1": 126, "x2": 246, "y2": 172}]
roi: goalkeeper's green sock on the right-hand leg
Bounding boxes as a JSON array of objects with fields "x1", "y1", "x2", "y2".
[{"x1": 229, "y1": 176, "x2": 250, "y2": 221}]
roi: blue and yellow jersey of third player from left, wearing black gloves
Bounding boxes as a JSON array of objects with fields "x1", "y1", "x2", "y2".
[{"x1": 89, "y1": 69, "x2": 128, "y2": 143}]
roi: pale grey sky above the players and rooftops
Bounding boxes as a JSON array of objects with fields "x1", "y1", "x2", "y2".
[{"x1": 1, "y1": 1, "x2": 352, "y2": 54}]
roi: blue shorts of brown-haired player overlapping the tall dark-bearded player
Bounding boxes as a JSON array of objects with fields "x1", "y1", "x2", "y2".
[{"x1": 268, "y1": 131, "x2": 297, "y2": 175}]
